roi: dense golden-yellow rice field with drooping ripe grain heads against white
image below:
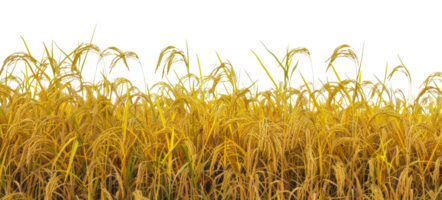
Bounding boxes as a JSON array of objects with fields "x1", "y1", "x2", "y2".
[{"x1": 0, "y1": 21, "x2": 442, "y2": 200}]
